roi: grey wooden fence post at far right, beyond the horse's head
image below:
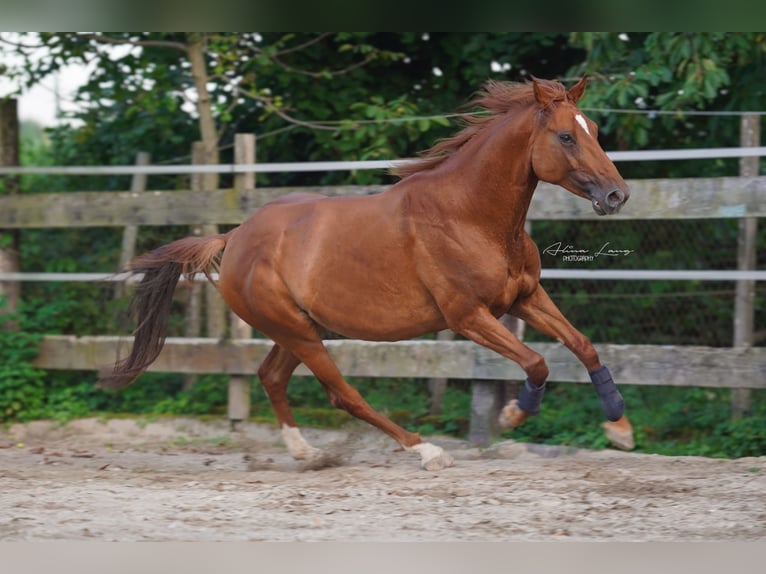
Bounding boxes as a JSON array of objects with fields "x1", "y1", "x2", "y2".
[{"x1": 731, "y1": 114, "x2": 761, "y2": 419}]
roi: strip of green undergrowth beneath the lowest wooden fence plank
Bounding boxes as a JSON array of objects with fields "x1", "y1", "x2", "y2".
[{"x1": 12, "y1": 373, "x2": 766, "y2": 458}]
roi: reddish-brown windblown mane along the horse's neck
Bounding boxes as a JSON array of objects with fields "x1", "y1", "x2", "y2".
[{"x1": 393, "y1": 80, "x2": 567, "y2": 178}]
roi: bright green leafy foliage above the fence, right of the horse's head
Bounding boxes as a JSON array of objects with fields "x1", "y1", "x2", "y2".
[{"x1": 570, "y1": 32, "x2": 766, "y2": 177}]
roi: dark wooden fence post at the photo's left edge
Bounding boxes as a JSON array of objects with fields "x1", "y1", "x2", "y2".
[{"x1": 0, "y1": 99, "x2": 21, "y2": 329}]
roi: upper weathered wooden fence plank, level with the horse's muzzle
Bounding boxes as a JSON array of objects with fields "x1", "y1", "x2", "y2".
[{"x1": 0, "y1": 176, "x2": 766, "y2": 229}]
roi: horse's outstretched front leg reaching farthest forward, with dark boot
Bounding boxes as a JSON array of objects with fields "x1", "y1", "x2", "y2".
[{"x1": 510, "y1": 285, "x2": 634, "y2": 450}]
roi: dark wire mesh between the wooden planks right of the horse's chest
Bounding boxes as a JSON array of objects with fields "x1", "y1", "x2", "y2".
[{"x1": 525, "y1": 219, "x2": 766, "y2": 347}]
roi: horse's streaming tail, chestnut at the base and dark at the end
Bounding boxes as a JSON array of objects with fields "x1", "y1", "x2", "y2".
[{"x1": 99, "y1": 233, "x2": 229, "y2": 388}]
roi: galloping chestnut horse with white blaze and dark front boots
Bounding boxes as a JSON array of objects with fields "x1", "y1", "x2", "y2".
[{"x1": 101, "y1": 78, "x2": 630, "y2": 470}]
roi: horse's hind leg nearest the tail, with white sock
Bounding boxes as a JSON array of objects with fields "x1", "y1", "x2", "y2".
[{"x1": 258, "y1": 345, "x2": 321, "y2": 460}]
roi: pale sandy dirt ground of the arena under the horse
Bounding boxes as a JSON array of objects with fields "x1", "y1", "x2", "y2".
[{"x1": 0, "y1": 419, "x2": 766, "y2": 542}]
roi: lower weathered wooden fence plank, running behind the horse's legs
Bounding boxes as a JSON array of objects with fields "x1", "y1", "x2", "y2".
[{"x1": 35, "y1": 335, "x2": 766, "y2": 389}]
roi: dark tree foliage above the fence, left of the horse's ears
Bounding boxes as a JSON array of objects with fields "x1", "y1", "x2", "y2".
[{"x1": 1, "y1": 32, "x2": 581, "y2": 181}]
